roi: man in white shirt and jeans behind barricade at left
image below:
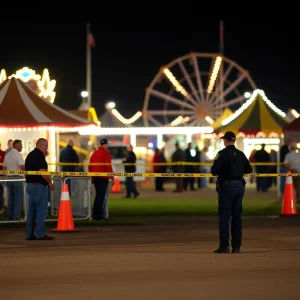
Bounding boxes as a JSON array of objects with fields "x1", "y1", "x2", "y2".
[{"x1": 3, "y1": 140, "x2": 25, "y2": 221}]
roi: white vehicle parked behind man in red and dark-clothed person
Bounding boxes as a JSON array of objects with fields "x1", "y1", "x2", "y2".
[{"x1": 107, "y1": 143, "x2": 146, "y2": 182}]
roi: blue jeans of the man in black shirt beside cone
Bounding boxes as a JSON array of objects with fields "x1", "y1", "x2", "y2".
[{"x1": 26, "y1": 183, "x2": 49, "y2": 238}]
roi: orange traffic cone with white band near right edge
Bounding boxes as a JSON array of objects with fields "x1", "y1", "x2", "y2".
[{"x1": 280, "y1": 171, "x2": 298, "y2": 216}]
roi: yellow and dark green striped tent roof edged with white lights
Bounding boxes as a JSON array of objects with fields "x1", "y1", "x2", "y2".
[{"x1": 215, "y1": 90, "x2": 289, "y2": 136}]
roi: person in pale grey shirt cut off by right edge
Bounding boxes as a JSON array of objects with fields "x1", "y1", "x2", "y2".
[{"x1": 284, "y1": 144, "x2": 300, "y2": 203}]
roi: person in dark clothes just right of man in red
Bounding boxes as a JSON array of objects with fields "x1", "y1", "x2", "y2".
[{"x1": 123, "y1": 145, "x2": 140, "y2": 198}]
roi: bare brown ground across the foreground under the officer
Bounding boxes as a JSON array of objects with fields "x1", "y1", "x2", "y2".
[{"x1": 0, "y1": 217, "x2": 300, "y2": 300}]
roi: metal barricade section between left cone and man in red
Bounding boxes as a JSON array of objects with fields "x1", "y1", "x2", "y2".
[{"x1": 64, "y1": 177, "x2": 91, "y2": 220}]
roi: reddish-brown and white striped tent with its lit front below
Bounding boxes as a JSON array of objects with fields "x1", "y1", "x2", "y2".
[{"x1": 0, "y1": 77, "x2": 97, "y2": 165}]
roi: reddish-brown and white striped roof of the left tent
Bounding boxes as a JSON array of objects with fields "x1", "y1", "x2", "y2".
[{"x1": 0, "y1": 77, "x2": 95, "y2": 131}]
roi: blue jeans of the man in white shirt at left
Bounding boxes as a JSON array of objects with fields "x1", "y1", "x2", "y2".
[{"x1": 7, "y1": 181, "x2": 24, "y2": 221}]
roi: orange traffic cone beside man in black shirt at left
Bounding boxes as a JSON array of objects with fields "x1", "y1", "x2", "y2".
[{"x1": 53, "y1": 184, "x2": 78, "y2": 232}]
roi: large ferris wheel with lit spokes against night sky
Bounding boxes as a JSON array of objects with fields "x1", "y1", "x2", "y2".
[{"x1": 143, "y1": 53, "x2": 256, "y2": 127}]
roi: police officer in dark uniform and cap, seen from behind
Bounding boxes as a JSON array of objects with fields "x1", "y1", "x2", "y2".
[{"x1": 211, "y1": 131, "x2": 252, "y2": 253}]
